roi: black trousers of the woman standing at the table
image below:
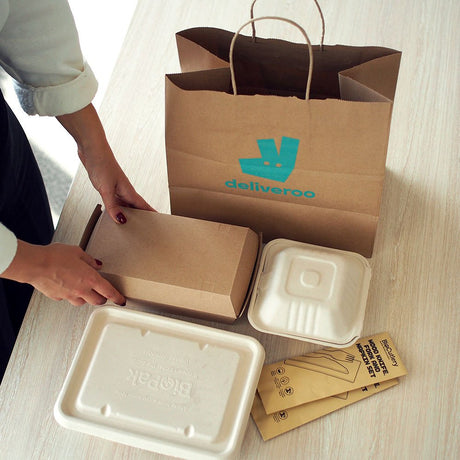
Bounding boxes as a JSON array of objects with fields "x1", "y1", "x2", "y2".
[{"x1": 0, "y1": 92, "x2": 54, "y2": 380}]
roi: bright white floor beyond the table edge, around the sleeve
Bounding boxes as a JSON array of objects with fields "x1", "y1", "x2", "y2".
[{"x1": 0, "y1": 0, "x2": 137, "y2": 225}]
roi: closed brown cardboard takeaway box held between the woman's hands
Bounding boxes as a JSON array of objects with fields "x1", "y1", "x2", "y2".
[{"x1": 81, "y1": 208, "x2": 260, "y2": 322}]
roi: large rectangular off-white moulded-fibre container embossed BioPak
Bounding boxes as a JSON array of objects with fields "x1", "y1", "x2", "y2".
[{"x1": 54, "y1": 306, "x2": 265, "y2": 459}]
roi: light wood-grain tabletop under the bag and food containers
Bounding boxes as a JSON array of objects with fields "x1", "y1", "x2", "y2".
[{"x1": 0, "y1": 0, "x2": 460, "y2": 460}]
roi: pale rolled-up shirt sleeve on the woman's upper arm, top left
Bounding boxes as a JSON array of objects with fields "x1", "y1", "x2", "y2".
[{"x1": 0, "y1": 0, "x2": 97, "y2": 116}]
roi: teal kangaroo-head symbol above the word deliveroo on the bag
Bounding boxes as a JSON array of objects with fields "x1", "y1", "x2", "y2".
[{"x1": 239, "y1": 136, "x2": 299, "y2": 182}]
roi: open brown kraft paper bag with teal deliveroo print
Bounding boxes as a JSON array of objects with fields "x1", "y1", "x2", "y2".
[{"x1": 165, "y1": 18, "x2": 401, "y2": 257}]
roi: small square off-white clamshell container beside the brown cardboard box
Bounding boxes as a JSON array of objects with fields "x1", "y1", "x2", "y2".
[{"x1": 248, "y1": 239, "x2": 371, "y2": 348}]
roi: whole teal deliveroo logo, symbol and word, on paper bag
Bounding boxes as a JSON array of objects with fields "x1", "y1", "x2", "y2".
[{"x1": 225, "y1": 136, "x2": 315, "y2": 198}]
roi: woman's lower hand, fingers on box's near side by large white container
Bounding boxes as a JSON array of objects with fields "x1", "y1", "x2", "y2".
[{"x1": 2, "y1": 240, "x2": 126, "y2": 306}]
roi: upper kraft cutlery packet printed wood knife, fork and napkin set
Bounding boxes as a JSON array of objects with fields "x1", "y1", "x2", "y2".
[{"x1": 257, "y1": 333, "x2": 407, "y2": 414}]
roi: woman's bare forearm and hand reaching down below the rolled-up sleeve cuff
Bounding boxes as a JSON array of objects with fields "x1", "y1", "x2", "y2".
[{"x1": 57, "y1": 104, "x2": 155, "y2": 224}]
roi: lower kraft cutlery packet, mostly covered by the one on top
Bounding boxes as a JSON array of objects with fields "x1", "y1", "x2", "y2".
[{"x1": 251, "y1": 379, "x2": 399, "y2": 441}]
